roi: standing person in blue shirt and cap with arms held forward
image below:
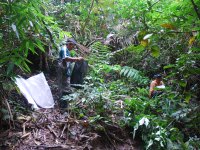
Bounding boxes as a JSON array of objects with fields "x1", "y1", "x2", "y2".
[{"x1": 59, "y1": 39, "x2": 84, "y2": 88}]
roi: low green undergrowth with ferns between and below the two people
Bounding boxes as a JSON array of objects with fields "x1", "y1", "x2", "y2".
[{"x1": 65, "y1": 43, "x2": 200, "y2": 150}]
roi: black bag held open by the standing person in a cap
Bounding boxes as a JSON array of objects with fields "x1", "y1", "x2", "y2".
[{"x1": 70, "y1": 60, "x2": 88, "y2": 84}]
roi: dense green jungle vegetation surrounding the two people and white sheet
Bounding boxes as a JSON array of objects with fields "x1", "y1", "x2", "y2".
[{"x1": 0, "y1": 0, "x2": 200, "y2": 150}]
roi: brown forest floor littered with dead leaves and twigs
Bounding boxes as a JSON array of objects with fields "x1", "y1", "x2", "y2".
[{"x1": 0, "y1": 74, "x2": 141, "y2": 150}]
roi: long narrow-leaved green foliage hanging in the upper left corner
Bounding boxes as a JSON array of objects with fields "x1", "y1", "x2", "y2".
[{"x1": 0, "y1": 0, "x2": 65, "y2": 75}]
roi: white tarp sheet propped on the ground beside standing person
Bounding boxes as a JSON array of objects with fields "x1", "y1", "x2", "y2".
[{"x1": 15, "y1": 73, "x2": 54, "y2": 109}]
